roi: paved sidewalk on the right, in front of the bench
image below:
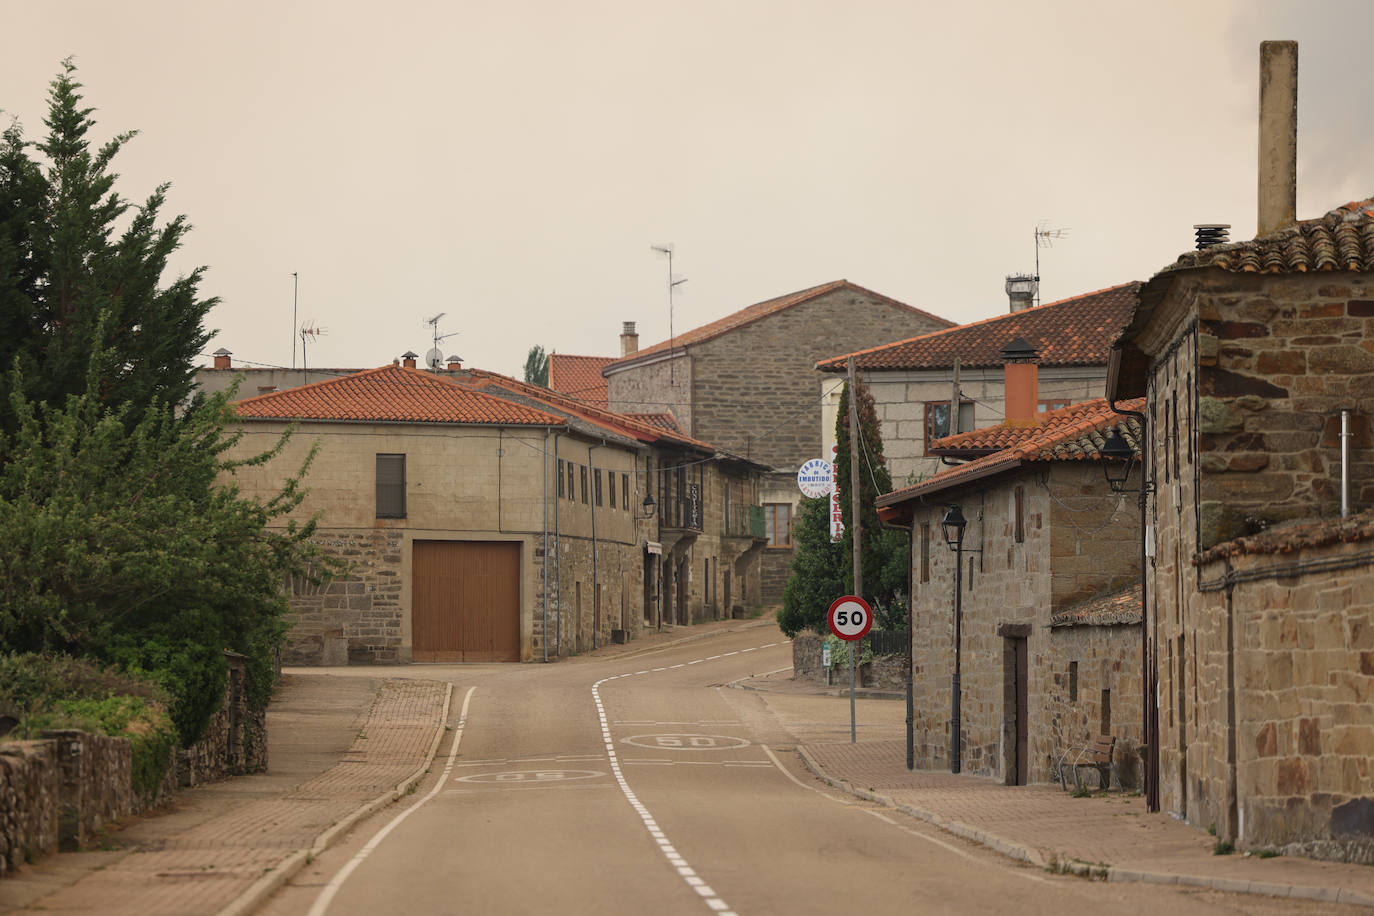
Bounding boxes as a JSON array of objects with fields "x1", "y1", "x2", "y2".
[{"x1": 735, "y1": 673, "x2": 1374, "y2": 906}]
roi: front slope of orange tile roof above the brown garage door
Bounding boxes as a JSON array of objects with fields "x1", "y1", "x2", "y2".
[{"x1": 232, "y1": 365, "x2": 563, "y2": 426}]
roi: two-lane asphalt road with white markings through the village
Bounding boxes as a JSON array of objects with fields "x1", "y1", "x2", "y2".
[{"x1": 262, "y1": 626, "x2": 1352, "y2": 916}]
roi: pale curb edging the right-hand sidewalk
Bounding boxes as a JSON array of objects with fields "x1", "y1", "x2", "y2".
[{"x1": 791, "y1": 747, "x2": 1374, "y2": 908}]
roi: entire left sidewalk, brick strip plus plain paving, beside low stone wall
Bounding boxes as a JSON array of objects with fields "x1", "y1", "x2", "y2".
[{"x1": 0, "y1": 676, "x2": 451, "y2": 916}]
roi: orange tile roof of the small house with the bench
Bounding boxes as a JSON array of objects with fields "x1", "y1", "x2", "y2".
[{"x1": 877, "y1": 398, "x2": 1145, "y2": 507}]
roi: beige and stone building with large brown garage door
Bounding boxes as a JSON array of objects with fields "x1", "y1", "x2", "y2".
[{"x1": 223, "y1": 360, "x2": 761, "y2": 665}]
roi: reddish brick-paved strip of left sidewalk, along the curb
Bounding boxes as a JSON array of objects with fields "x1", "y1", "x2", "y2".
[{"x1": 2, "y1": 677, "x2": 449, "y2": 916}]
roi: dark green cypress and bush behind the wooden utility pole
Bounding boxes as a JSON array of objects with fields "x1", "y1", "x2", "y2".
[{"x1": 778, "y1": 376, "x2": 907, "y2": 636}]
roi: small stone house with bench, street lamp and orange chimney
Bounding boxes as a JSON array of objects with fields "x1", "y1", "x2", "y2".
[{"x1": 878, "y1": 395, "x2": 1143, "y2": 786}]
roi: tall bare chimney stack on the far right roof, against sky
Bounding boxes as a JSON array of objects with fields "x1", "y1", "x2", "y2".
[{"x1": 1256, "y1": 41, "x2": 1297, "y2": 235}]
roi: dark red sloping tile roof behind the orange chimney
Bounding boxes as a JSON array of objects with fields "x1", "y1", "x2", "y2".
[{"x1": 816, "y1": 282, "x2": 1140, "y2": 372}]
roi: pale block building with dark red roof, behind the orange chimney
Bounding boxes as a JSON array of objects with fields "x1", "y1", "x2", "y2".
[{"x1": 816, "y1": 283, "x2": 1140, "y2": 483}]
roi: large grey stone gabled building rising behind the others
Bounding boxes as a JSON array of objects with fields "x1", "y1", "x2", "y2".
[{"x1": 603, "y1": 280, "x2": 952, "y2": 602}]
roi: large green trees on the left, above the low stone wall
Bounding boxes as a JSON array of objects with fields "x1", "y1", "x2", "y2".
[{"x1": 0, "y1": 62, "x2": 334, "y2": 743}]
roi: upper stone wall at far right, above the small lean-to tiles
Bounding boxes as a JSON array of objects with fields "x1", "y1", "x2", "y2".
[{"x1": 1192, "y1": 272, "x2": 1374, "y2": 549}]
